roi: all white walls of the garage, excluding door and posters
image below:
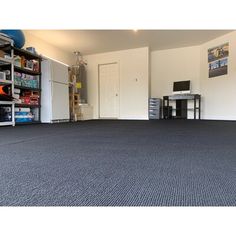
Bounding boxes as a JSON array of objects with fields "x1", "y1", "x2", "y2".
[{"x1": 24, "y1": 31, "x2": 236, "y2": 120}]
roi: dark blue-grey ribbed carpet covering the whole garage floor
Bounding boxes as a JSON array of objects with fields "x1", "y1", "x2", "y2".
[{"x1": 0, "y1": 120, "x2": 236, "y2": 206}]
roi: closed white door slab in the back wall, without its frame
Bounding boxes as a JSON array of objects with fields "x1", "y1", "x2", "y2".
[{"x1": 99, "y1": 63, "x2": 119, "y2": 119}]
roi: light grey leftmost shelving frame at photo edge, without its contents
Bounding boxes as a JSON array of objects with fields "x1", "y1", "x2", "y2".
[{"x1": 0, "y1": 35, "x2": 15, "y2": 126}]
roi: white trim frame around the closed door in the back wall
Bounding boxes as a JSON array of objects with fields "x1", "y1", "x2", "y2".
[{"x1": 98, "y1": 61, "x2": 120, "y2": 120}]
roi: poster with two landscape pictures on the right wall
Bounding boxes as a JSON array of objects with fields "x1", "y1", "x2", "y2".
[{"x1": 208, "y1": 43, "x2": 229, "y2": 78}]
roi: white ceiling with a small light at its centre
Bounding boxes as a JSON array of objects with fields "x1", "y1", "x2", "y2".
[{"x1": 26, "y1": 30, "x2": 231, "y2": 55}]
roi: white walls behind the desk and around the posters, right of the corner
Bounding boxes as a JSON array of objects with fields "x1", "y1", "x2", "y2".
[{"x1": 151, "y1": 32, "x2": 236, "y2": 120}]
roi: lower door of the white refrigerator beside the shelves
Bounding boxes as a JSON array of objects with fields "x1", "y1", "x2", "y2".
[{"x1": 52, "y1": 82, "x2": 69, "y2": 120}]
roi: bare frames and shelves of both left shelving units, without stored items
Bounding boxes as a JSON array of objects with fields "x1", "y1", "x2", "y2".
[{"x1": 0, "y1": 34, "x2": 42, "y2": 126}]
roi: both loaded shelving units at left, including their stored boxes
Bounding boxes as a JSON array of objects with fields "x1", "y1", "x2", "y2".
[{"x1": 0, "y1": 33, "x2": 42, "y2": 125}]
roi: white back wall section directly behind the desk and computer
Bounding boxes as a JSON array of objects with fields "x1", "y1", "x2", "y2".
[{"x1": 151, "y1": 46, "x2": 200, "y2": 118}]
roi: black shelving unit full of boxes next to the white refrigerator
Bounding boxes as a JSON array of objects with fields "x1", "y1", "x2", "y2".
[{"x1": 14, "y1": 45, "x2": 42, "y2": 124}]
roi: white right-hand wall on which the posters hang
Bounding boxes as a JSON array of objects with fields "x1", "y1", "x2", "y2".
[{"x1": 200, "y1": 32, "x2": 236, "y2": 120}]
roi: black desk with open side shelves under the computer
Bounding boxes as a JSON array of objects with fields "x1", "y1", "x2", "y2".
[{"x1": 163, "y1": 94, "x2": 201, "y2": 119}]
